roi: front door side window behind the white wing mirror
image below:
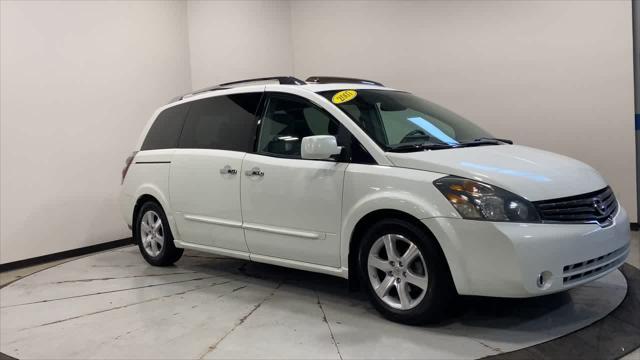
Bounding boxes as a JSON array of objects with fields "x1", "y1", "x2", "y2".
[{"x1": 257, "y1": 93, "x2": 340, "y2": 158}]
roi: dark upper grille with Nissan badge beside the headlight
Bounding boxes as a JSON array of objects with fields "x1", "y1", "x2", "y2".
[{"x1": 534, "y1": 186, "x2": 618, "y2": 226}]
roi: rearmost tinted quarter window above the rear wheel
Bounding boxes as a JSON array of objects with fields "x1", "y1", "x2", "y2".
[{"x1": 140, "y1": 104, "x2": 189, "y2": 150}]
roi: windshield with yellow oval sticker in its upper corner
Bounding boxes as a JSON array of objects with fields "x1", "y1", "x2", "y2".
[{"x1": 320, "y1": 89, "x2": 496, "y2": 151}]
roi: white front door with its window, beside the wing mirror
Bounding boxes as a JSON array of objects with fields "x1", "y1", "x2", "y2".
[{"x1": 241, "y1": 93, "x2": 348, "y2": 267}]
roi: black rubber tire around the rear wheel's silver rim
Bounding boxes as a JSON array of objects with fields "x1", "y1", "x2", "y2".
[{"x1": 133, "y1": 201, "x2": 184, "y2": 266}]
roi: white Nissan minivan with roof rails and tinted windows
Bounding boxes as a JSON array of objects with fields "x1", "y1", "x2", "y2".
[{"x1": 121, "y1": 77, "x2": 630, "y2": 324}]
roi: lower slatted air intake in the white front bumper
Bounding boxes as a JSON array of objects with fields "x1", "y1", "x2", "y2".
[{"x1": 562, "y1": 245, "x2": 629, "y2": 285}]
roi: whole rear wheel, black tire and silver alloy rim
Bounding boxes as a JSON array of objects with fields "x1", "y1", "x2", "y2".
[{"x1": 133, "y1": 201, "x2": 184, "y2": 266}]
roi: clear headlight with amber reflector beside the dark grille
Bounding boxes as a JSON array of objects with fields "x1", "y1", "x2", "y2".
[{"x1": 433, "y1": 176, "x2": 540, "y2": 222}]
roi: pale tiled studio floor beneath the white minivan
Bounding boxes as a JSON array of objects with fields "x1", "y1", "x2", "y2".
[{"x1": 0, "y1": 232, "x2": 640, "y2": 359}]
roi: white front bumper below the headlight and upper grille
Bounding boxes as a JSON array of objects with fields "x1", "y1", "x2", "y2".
[{"x1": 422, "y1": 206, "x2": 631, "y2": 297}]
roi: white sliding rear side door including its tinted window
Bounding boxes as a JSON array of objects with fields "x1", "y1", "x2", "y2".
[{"x1": 169, "y1": 92, "x2": 262, "y2": 253}]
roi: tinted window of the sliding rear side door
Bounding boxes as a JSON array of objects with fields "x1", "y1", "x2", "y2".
[{"x1": 180, "y1": 93, "x2": 262, "y2": 152}]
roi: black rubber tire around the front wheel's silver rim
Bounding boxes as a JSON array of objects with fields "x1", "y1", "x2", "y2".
[{"x1": 358, "y1": 219, "x2": 456, "y2": 325}]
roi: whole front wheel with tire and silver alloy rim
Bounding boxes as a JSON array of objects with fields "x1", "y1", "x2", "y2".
[{"x1": 359, "y1": 219, "x2": 455, "y2": 324}]
